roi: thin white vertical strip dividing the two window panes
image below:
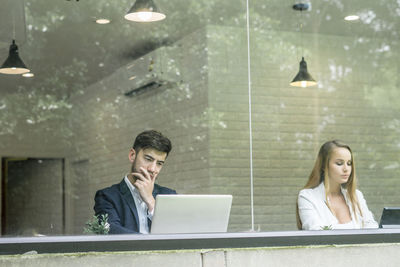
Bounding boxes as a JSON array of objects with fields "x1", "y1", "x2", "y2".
[{"x1": 246, "y1": 0, "x2": 254, "y2": 231}]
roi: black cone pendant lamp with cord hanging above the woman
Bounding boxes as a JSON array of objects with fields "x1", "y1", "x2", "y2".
[{"x1": 290, "y1": 3, "x2": 317, "y2": 87}]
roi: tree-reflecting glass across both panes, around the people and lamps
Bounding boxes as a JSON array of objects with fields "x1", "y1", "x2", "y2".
[{"x1": 0, "y1": 0, "x2": 400, "y2": 239}]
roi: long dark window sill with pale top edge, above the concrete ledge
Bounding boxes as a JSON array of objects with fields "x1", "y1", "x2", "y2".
[{"x1": 0, "y1": 229, "x2": 400, "y2": 255}]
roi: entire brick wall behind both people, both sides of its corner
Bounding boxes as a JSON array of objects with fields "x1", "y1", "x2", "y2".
[{"x1": 0, "y1": 26, "x2": 400, "y2": 234}]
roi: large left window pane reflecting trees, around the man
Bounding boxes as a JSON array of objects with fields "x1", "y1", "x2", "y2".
[{"x1": 0, "y1": 0, "x2": 250, "y2": 235}]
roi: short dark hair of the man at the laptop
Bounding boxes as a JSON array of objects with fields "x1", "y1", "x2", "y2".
[{"x1": 133, "y1": 130, "x2": 172, "y2": 156}]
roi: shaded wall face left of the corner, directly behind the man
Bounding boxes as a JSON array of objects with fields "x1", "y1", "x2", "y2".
[{"x1": 70, "y1": 30, "x2": 209, "y2": 234}]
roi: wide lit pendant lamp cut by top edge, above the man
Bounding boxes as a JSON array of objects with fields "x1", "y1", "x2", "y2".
[{"x1": 125, "y1": 0, "x2": 165, "y2": 22}]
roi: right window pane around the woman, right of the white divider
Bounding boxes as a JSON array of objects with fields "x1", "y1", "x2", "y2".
[{"x1": 250, "y1": 1, "x2": 400, "y2": 231}]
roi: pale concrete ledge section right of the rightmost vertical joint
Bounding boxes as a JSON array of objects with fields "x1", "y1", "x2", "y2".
[{"x1": 225, "y1": 244, "x2": 400, "y2": 267}]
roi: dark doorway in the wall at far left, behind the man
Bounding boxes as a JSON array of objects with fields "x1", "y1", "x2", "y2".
[{"x1": 1, "y1": 158, "x2": 65, "y2": 236}]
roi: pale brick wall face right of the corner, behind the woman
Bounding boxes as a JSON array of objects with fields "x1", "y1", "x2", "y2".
[{"x1": 208, "y1": 26, "x2": 400, "y2": 231}]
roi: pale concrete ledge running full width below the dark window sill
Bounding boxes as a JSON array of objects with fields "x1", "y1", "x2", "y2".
[{"x1": 0, "y1": 243, "x2": 400, "y2": 267}]
